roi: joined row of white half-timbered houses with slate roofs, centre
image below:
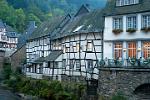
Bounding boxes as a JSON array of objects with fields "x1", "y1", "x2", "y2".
[{"x1": 26, "y1": 6, "x2": 103, "y2": 80}]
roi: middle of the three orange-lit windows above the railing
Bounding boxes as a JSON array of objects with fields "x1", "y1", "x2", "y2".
[{"x1": 128, "y1": 42, "x2": 136, "y2": 58}]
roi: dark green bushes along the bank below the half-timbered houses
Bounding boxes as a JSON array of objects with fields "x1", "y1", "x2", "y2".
[{"x1": 2, "y1": 74, "x2": 85, "y2": 100}]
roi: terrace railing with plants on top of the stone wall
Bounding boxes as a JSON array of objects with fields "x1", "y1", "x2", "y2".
[{"x1": 99, "y1": 58, "x2": 150, "y2": 68}]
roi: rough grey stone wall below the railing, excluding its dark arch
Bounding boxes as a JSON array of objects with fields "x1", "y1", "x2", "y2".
[{"x1": 98, "y1": 68, "x2": 150, "y2": 97}]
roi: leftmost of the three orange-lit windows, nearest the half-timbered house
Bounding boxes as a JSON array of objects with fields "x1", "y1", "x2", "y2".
[{"x1": 114, "y1": 42, "x2": 122, "y2": 58}]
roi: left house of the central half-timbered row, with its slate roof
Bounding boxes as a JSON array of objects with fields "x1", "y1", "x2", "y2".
[{"x1": 26, "y1": 17, "x2": 70, "y2": 78}]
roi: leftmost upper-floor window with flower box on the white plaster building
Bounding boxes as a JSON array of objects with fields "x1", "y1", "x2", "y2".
[{"x1": 113, "y1": 18, "x2": 123, "y2": 29}]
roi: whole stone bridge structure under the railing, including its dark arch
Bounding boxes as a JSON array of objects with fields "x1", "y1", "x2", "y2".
[{"x1": 98, "y1": 66, "x2": 150, "y2": 100}]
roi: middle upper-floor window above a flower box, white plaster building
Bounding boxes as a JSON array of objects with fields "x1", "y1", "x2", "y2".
[{"x1": 127, "y1": 16, "x2": 137, "y2": 29}]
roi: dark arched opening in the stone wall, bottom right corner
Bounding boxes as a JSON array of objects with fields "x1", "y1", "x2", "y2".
[{"x1": 134, "y1": 83, "x2": 150, "y2": 100}]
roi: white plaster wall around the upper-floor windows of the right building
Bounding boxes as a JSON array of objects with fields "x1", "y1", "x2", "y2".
[{"x1": 104, "y1": 13, "x2": 150, "y2": 41}]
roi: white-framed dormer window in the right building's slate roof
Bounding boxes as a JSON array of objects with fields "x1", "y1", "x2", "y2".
[{"x1": 116, "y1": 0, "x2": 139, "y2": 6}]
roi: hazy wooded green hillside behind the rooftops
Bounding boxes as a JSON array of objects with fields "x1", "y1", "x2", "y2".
[{"x1": 0, "y1": 0, "x2": 105, "y2": 32}]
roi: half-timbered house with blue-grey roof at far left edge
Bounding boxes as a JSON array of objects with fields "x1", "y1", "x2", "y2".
[{"x1": 0, "y1": 19, "x2": 18, "y2": 56}]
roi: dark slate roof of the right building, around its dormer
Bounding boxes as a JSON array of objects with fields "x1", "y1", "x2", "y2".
[{"x1": 104, "y1": 0, "x2": 150, "y2": 16}]
